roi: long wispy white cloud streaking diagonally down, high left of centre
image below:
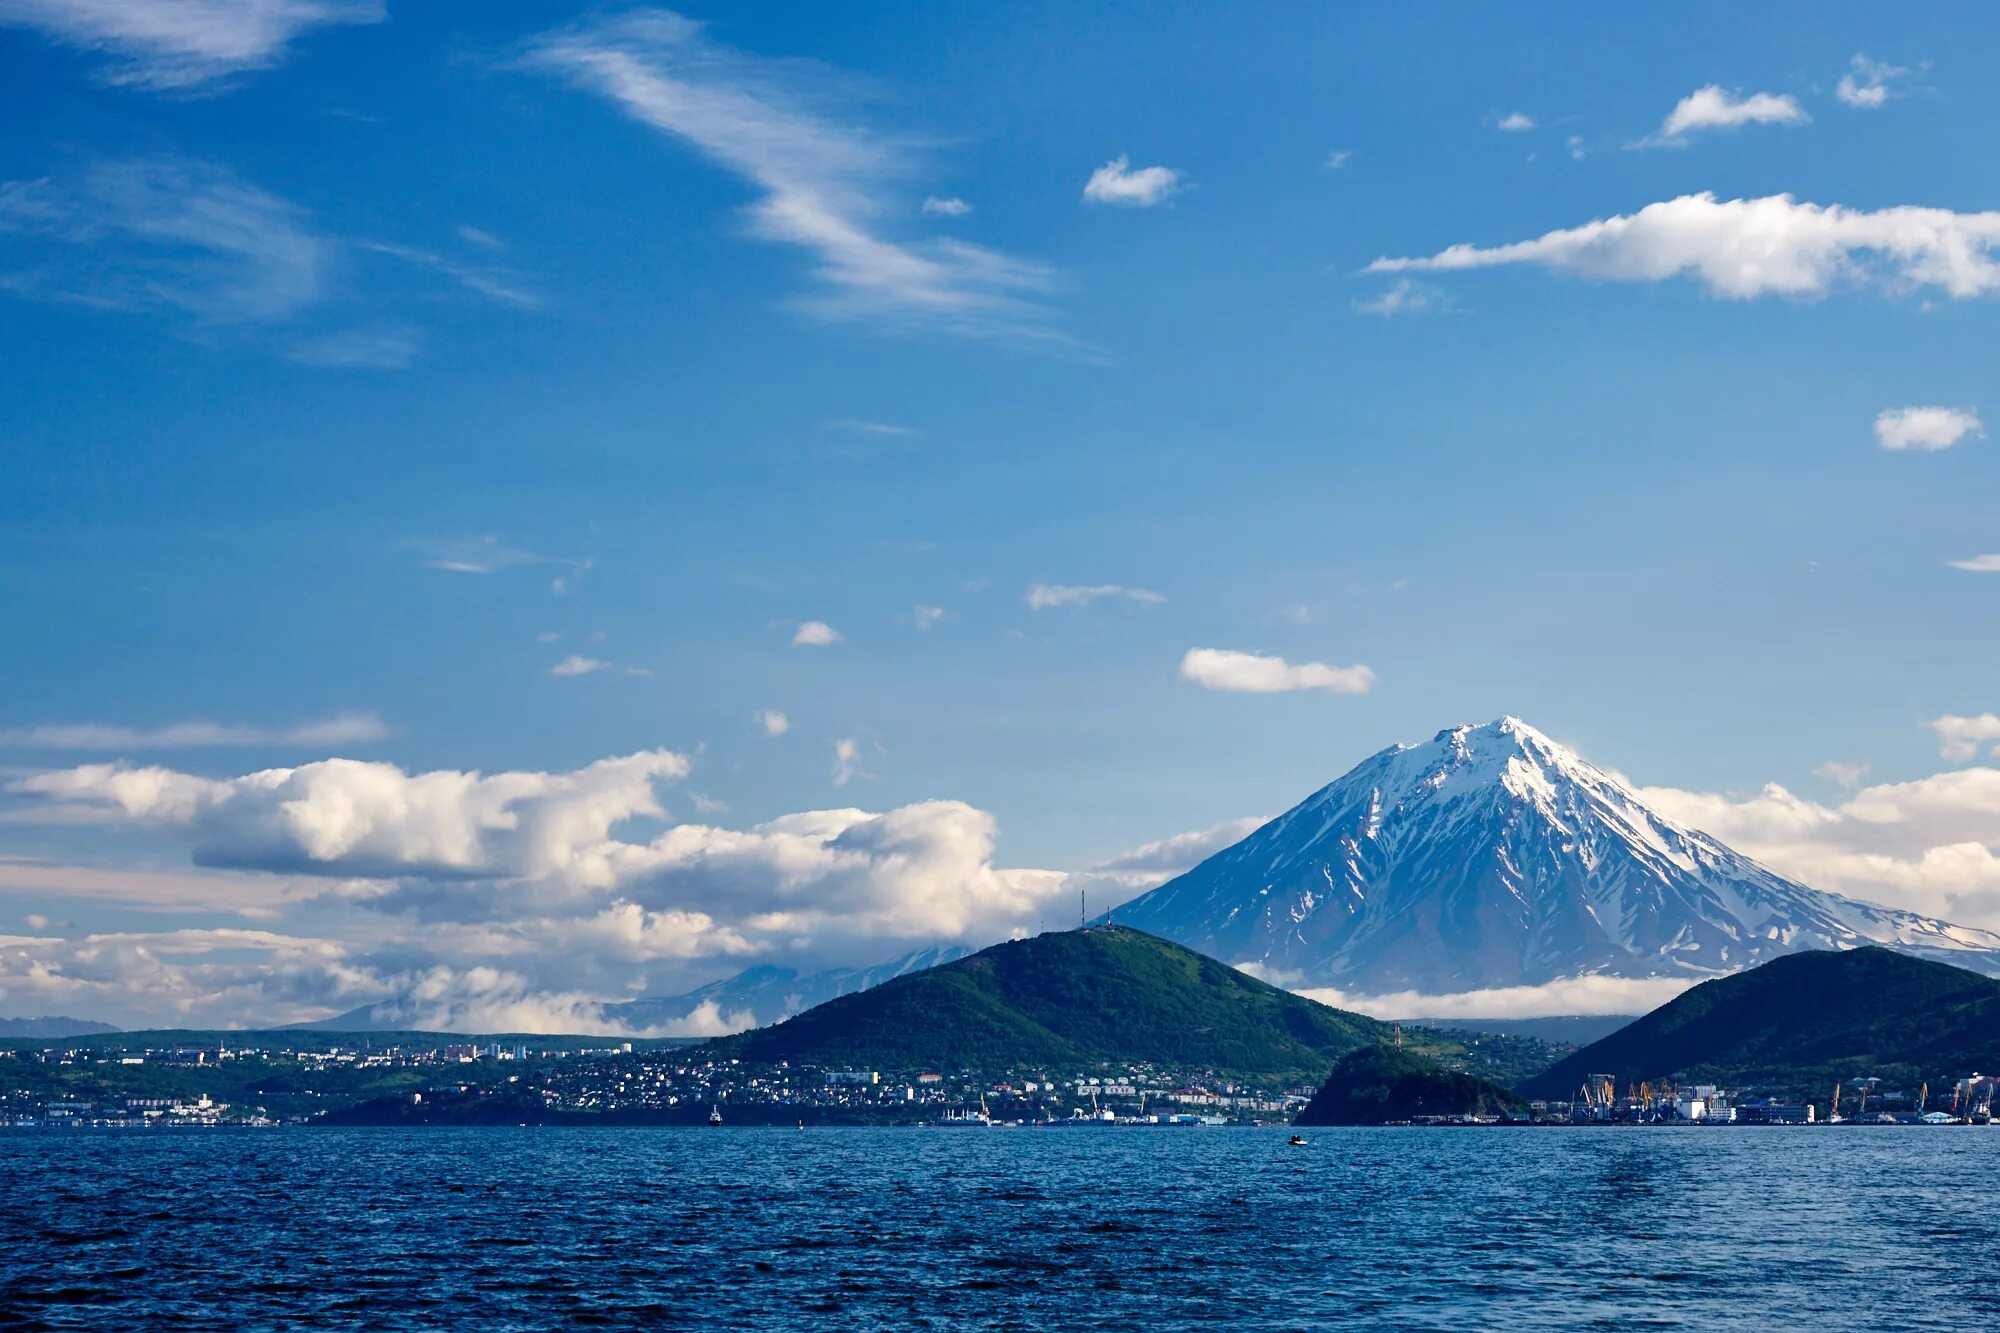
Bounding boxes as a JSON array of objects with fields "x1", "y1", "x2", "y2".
[{"x1": 524, "y1": 10, "x2": 1054, "y2": 338}]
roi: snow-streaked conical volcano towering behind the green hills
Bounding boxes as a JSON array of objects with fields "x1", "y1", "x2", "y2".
[{"x1": 1116, "y1": 717, "x2": 2000, "y2": 995}]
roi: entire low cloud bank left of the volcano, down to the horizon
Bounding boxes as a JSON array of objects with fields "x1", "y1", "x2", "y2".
[{"x1": 0, "y1": 747, "x2": 1074, "y2": 1031}]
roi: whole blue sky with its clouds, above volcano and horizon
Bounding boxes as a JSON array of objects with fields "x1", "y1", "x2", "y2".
[{"x1": 0, "y1": 0, "x2": 2000, "y2": 1031}]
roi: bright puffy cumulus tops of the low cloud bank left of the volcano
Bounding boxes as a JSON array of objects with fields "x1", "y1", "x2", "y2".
[{"x1": 8, "y1": 743, "x2": 1062, "y2": 953}]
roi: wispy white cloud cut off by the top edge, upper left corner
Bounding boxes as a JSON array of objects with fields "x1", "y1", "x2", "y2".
[{"x1": 0, "y1": 0, "x2": 384, "y2": 92}]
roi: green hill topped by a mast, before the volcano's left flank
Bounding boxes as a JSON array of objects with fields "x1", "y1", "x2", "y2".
[{"x1": 710, "y1": 927, "x2": 1388, "y2": 1077}]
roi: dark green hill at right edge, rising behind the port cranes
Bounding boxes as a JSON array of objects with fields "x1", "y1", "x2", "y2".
[{"x1": 1522, "y1": 949, "x2": 2000, "y2": 1099}]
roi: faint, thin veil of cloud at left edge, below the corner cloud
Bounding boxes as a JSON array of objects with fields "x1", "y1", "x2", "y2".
[{"x1": 0, "y1": 158, "x2": 334, "y2": 324}]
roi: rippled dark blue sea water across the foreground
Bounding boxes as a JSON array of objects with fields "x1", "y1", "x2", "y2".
[{"x1": 0, "y1": 1127, "x2": 2000, "y2": 1331}]
